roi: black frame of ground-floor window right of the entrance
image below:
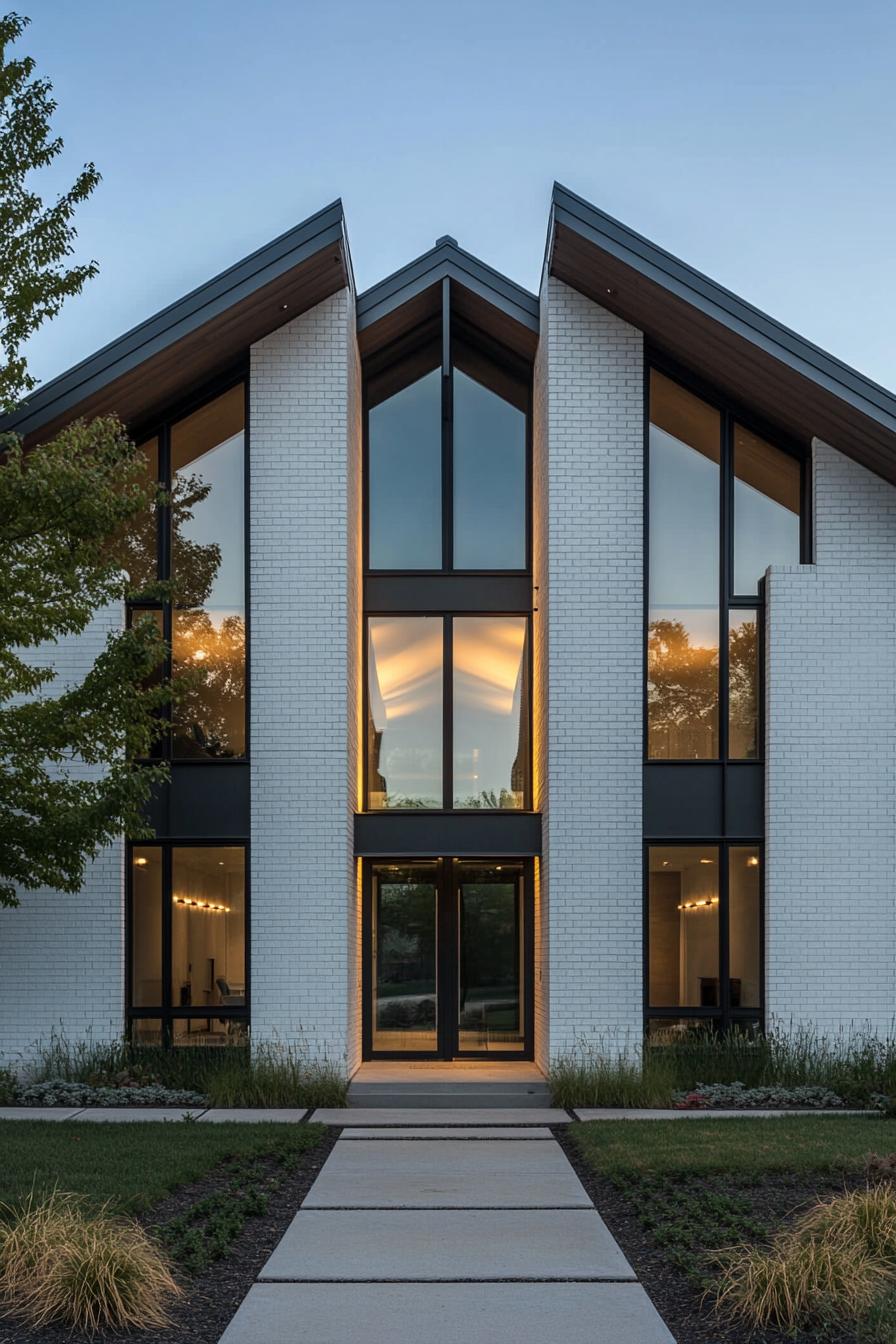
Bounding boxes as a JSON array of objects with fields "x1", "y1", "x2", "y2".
[{"x1": 642, "y1": 836, "x2": 766, "y2": 1038}]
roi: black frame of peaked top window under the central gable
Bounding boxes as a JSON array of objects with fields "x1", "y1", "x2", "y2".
[{"x1": 361, "y1": 278, "x2": 533, "y2": 581}]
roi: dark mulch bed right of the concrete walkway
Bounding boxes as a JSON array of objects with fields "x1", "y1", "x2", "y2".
[{"x1": 553, "y1": 1126, "x2": 865, "y2": 1344}]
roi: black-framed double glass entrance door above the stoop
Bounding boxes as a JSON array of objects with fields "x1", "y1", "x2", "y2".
[{"x1": 364, "y1": 859, "x2": 532, "y2": 1059}]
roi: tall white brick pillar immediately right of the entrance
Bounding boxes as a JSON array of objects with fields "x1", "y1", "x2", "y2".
[{"x1": 536, "y1": 277, "x2": 643, "y2": 1055}]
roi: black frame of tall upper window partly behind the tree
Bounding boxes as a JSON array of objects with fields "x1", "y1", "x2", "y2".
[{"x1": 125, "y1": 360, "x2": 251, "y2": 769}]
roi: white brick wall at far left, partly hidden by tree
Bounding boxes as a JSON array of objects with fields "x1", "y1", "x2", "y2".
[{"x1": 0, "y1": 606, "x2": 125, "y2": 1064}]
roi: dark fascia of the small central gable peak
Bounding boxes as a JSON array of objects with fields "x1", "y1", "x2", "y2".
[{"x1": 357, "y1": 239, "x2": 539, "y2": 333}]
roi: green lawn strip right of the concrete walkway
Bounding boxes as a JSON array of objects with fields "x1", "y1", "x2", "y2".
[{"x1": 570, "y1": 1116, "x2": 896, "y2": 1179}]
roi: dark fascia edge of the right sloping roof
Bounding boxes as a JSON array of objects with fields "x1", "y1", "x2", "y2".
[{"x1": 547, "y1": 183, "x2": 896, "y2": 433}]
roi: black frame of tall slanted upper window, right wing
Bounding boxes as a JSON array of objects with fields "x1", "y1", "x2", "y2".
[{"x1": 642, "y1": 349, "x2": 811, "y2": 768}]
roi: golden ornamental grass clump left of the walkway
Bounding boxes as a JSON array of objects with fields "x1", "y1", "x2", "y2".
[{"x1": 0, "y1": 1191, "x2": 181, "y2": 1333}]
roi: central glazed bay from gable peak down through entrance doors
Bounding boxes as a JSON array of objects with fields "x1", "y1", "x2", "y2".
[{"x1": 363, "y1": 281, "x2": 532, "y2": 1058}]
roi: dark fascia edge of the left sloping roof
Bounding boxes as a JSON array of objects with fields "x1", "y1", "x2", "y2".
[{"x1": 0, "y1": 200, "x2": 352, "y2": 435}]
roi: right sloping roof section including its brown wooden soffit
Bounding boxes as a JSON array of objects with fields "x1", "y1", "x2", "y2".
[{"x1": 547, "y1": 183, "x2": 896, "y2": 481}]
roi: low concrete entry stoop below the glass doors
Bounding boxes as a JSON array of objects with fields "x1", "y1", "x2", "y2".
[{"x1": 348, "y1": 1060, "x2": 551, "y2": 1110}]
